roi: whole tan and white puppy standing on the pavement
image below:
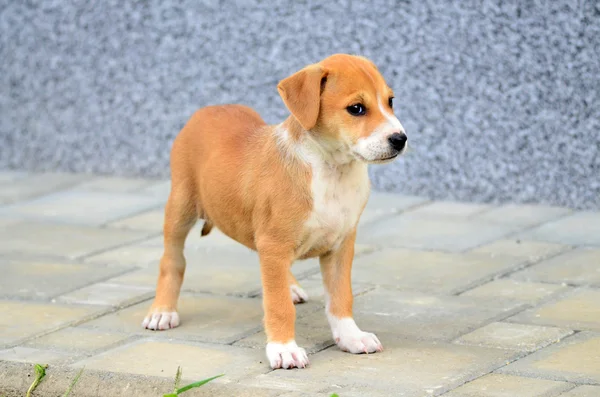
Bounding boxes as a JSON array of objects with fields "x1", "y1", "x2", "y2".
[{"x1": 143, "y1": 55, "x2": 406, "y2": 368}]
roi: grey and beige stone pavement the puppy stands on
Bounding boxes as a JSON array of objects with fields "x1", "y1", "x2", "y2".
[{"x1": 0, "y1": 172, "x2": 600, "y2": 397}]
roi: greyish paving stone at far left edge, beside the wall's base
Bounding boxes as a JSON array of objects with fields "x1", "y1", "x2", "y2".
[{"x1": 0, "y1": 173, "x2": 88, "y2": 204}]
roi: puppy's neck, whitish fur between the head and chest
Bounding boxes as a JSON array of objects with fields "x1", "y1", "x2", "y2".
[{"x1": 275, "y1": 116, "x2": 357, "y2": 168}]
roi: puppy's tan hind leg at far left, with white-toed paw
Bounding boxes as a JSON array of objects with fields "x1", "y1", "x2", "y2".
[{"x1": 142, "y1": 182, "x2": 198, "y2": 330}]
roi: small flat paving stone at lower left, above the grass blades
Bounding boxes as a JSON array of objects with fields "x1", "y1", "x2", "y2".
[{"x1": 24, "y1": 327, "x2": 129, "y2": 353}]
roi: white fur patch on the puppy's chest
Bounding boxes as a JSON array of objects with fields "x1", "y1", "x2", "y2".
[{"x1": 296, "y1": 157, "x2": 370, "y2": 257}]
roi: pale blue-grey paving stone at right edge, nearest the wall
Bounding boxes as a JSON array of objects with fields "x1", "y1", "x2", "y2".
[{"x1": 520, "y1": 211, "x2": 600, "y2": 246}]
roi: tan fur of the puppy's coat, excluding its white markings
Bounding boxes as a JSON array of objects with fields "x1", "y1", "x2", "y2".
[{"x1": 150, "y1": 55, "x2": 408, "y2": 358}]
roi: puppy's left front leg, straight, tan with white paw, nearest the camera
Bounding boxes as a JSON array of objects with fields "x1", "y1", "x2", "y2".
[{"x1": 257, "y1": 239, "x2": 308, "y2": 369}]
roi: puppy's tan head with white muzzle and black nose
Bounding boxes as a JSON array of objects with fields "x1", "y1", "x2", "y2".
[{"x1": 277, "y1": 54, "x2": 407, "y2": 163}]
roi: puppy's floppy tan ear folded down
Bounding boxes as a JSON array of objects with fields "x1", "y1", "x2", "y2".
[{"x1": 277, "y1": 64, "x2": 327, "y2": 130}]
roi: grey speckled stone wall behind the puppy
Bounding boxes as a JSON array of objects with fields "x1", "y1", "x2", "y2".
[{"x1": 0, "y1": 0, "x2": 600, "y2": 208}]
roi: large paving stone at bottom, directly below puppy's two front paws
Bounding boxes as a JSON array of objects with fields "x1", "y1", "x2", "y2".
[{"x1": 251, "y1": 341, "x2": 513, "y2": 397}]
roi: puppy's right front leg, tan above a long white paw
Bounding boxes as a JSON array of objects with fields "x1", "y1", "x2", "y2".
[{"x1": 320, "y1": 229, "x2": 383, "y2": 353}]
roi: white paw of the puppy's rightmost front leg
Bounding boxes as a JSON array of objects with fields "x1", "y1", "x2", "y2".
[{"x1": 330, "y1": 318, "x2": 383, "y2": 354}]
